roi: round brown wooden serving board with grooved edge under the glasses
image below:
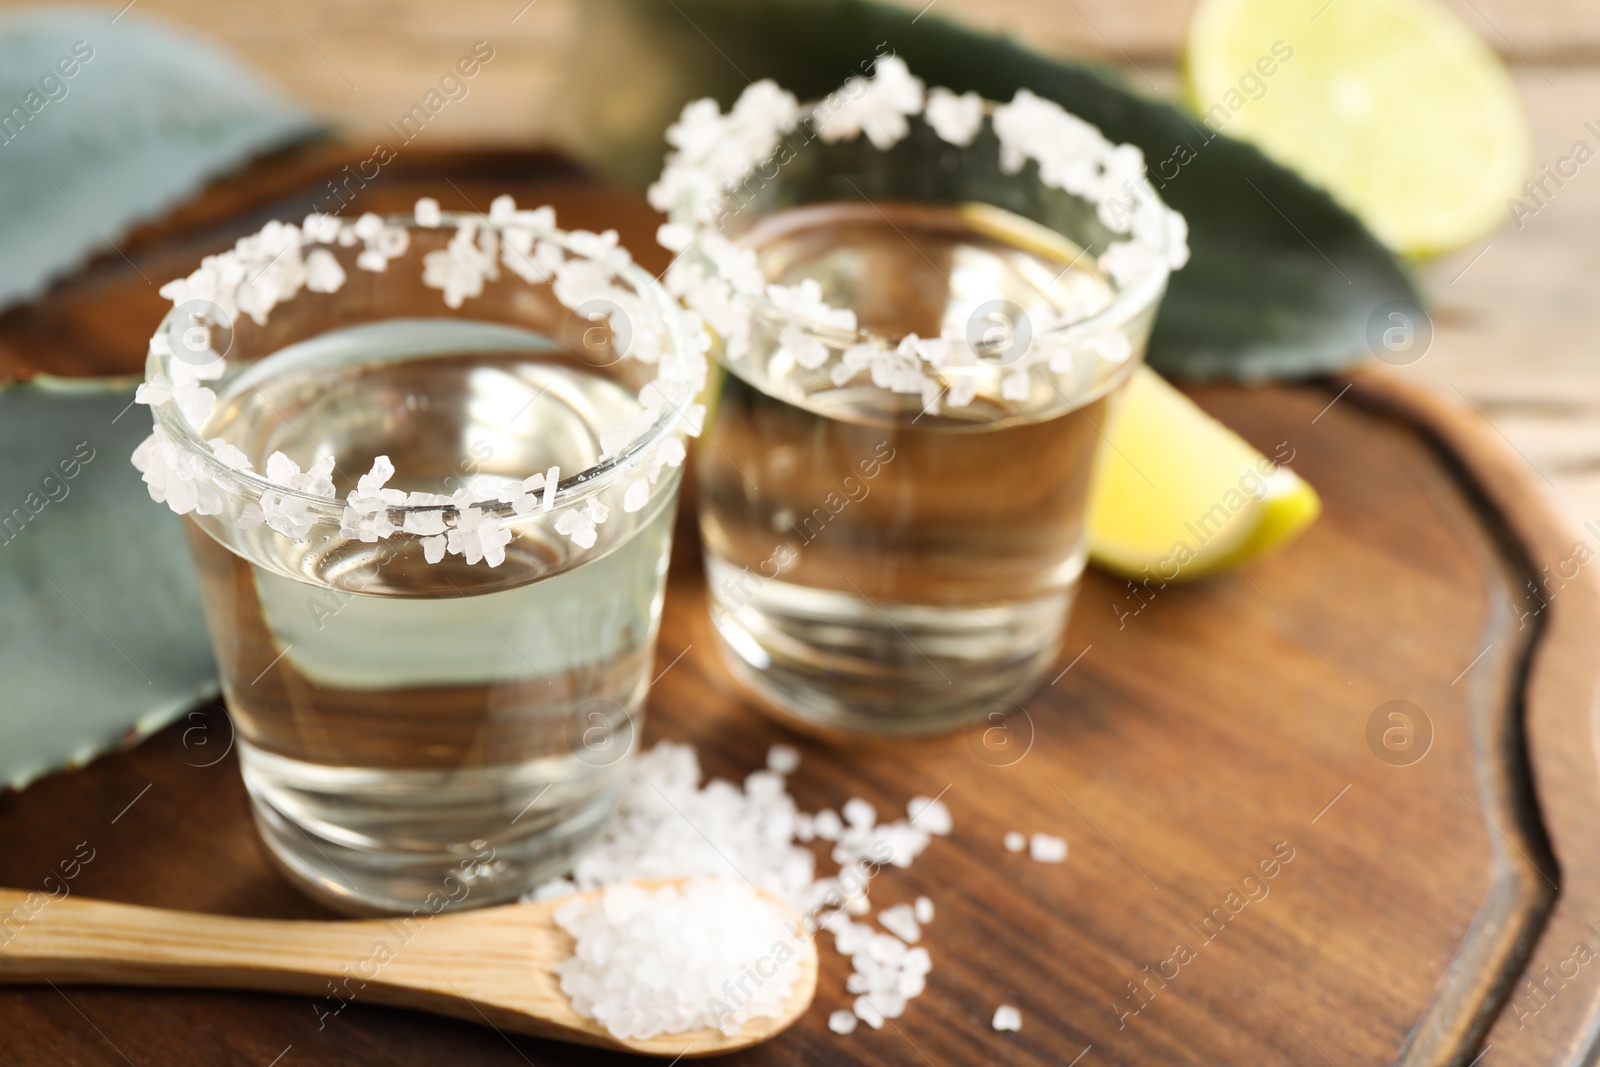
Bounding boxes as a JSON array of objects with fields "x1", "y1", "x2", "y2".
[{"x1": 0, "y1": 147, "x2": 1600, "y2": 1067}]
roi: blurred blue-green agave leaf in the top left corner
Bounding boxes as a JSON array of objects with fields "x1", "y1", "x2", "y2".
[{"x1": 0, "y1": 3, "x2": 318, "y2": 316}]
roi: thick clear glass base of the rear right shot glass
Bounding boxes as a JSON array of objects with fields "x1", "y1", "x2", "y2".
[{"x1": 707, "y1": 558, "x2": 1077, "y2": 736}]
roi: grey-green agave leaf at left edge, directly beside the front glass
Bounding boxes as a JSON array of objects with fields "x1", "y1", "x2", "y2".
[{"x1": 0, "y1": 378, "x2": 218, "y2": 789}]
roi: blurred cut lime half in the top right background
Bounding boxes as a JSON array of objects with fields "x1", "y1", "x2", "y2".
[{"x1": 1186, "y1": 0, "x2": 1530, "y2": 256}]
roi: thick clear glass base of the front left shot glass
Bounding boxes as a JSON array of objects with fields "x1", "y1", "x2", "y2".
[{"x1": 240, "y1": 741, "x2": 632, "y2": 915}]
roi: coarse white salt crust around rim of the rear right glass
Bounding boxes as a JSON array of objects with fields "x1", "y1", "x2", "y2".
[{"x1": 650, "y1": 65, "x2": 1189, "y2": 413}]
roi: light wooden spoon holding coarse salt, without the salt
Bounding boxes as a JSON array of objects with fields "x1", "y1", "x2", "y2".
[{"x1": 0, "y1": 881, "x2": 818, "y2": 1057}]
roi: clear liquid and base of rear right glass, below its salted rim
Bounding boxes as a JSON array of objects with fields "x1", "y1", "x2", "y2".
[{"x1": 698, "y1": 202, "x2": 1125, "y2": 734}]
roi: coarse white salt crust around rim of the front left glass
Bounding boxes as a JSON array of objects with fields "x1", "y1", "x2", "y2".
[{"x1": 133, "y1": 197, "x2": 710, "y2": 566}]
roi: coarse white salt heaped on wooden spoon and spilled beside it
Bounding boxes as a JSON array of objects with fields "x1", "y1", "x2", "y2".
[{"x1": 533, "y1": 742, "x2": 952, "y2": 1037}]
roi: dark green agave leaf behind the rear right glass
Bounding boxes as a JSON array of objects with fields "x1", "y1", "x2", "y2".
[{"x1": 557, "y1": 0, "x2": 1419, "y2": 379}]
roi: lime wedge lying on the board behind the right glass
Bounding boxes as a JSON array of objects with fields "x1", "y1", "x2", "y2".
[{"x1": 1090, "y1": 368, "x2": 1322, "y2": 582}]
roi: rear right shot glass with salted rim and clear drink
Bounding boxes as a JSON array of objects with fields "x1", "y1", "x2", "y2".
[{"x1": 651, "y1": 56, "x2": 1187, "y2": 734}]
